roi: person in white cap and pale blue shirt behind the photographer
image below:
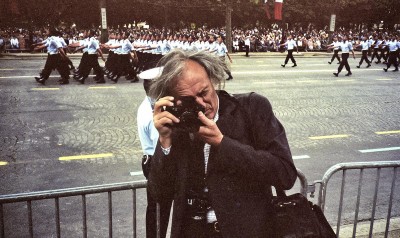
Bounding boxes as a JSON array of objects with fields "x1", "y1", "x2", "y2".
[{"x1": 137, "y1": 67, "x2": 172, "y2": 238}]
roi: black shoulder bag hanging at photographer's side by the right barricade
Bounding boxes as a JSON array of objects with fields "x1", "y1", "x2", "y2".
[{"x1": 235, "y1": 93, "x2": 336, "y2": 238}]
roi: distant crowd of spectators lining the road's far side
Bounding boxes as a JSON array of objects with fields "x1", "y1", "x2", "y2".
[{"x1": 0, "y1": 24, "x2": 394, "y2": 52}]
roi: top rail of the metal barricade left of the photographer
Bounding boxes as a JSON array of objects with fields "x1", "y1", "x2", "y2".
[{"x1": 0, "y1": 180, "x2": 147, "y2": 204}]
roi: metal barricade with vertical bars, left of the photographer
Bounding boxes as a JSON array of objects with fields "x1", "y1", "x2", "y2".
[{"x1": 0, "y1": 180, "x2": 147, "y2": 238}]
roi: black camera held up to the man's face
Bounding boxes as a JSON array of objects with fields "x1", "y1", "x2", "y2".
[{"x1": 165, "y1": 96, "x2": 205, "y2": 132}]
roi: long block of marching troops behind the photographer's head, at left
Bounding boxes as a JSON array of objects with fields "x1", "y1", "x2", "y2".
[{"x1": 34, "y1": 29, "x2": 233, "y2": 84}]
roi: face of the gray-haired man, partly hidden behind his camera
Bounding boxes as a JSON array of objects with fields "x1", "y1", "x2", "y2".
[{"x1": 172, "y1": 60, "x2": 218, "y2": 119}]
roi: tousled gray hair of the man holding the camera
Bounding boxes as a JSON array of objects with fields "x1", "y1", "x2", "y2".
[{"x1": 149, "y1": 50, "x2": 226, "y2": 100}]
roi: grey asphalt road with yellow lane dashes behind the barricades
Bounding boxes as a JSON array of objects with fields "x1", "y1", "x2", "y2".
[{"x1": 0, "y1": 54, "x2": 400, "y2": 237}]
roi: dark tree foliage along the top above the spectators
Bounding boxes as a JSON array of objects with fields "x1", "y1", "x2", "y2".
[{"x1": 4, "y1": 0, "x2": 400, "y2": 27}]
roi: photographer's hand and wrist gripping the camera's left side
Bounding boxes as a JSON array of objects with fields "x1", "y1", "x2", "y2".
[{"x1": 153, "y1": 96, "x2": 179, "y2": 148}]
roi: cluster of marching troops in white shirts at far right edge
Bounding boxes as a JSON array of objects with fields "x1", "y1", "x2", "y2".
[{"x1": 328, "y1": 35, "x2": 400, "y2": 76}]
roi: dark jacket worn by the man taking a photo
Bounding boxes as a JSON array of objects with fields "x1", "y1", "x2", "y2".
[{"x1": 148, "y1": 91, "x2": 297, "y2": 238}]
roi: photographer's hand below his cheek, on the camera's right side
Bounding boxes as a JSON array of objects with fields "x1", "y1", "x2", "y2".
[{"x1": 197, "y1": 112, "x2": 224, "y2": 146}]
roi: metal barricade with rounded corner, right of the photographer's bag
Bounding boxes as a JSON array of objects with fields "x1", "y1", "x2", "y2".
[{"x1": 311, "y1": 161, "x2": 400, "y2": 237}]
